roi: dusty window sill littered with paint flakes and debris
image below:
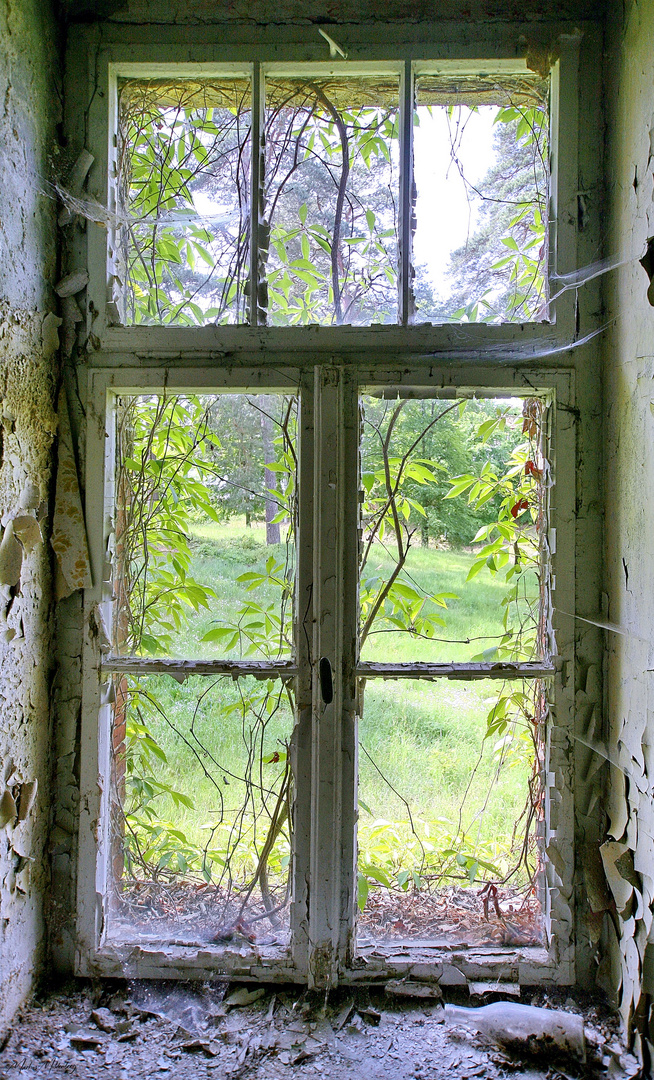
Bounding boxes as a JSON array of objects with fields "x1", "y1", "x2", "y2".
[{"x1": 0, "y1": 981, "x2": 635, "y2": 1080}]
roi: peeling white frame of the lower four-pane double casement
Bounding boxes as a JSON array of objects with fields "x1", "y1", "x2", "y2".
[{"x1": 78, "y1": 364, "x2": 575, "y2": 985}]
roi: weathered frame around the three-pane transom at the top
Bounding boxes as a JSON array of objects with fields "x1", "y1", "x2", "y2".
[{"x1": 64, "y1": 29, "x2": 578, "y2": 347}]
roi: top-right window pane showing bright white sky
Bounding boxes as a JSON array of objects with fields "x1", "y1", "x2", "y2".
[{"x1": 413, "y1": 76, "x2": 548, "y2": 323}]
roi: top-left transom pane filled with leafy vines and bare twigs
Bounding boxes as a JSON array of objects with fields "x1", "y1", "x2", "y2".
[{"x1": 117, "y1": 79, "x2": 251, "y2": 326}]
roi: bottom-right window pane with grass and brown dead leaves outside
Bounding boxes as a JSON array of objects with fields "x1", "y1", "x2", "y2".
[{"x1": 358, "y1": 679, "x2": 546, "y2": 947}]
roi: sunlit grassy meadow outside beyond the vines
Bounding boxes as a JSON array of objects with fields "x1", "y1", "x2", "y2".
[{"x1": 120, "y1": 518, "x2": 541, "y2": 888}]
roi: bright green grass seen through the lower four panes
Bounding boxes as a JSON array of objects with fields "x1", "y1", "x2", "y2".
[{"x1": 120, "y1": 522, "x2": 541, "y2": 894}]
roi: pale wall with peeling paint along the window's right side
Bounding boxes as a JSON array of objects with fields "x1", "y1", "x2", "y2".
[{"x1": 600, "y1": 3, "x2": 654, "y2": 1062}]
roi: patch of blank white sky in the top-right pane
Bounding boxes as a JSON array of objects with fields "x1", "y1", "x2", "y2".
[{"x1": 413, "y1": 106, "x2": 498, "y2": 297}]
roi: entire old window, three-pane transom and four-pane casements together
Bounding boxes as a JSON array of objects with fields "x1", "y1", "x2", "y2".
[{"x1": 71, "y1": 33, "x2": 574, "y2": 985}]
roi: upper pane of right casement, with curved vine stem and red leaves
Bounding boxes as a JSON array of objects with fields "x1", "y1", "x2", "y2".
[{"x1": 359, "y1": 391, "x2": 549, "y2": 662}]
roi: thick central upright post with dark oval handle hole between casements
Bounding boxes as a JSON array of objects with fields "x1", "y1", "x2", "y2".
[{"x1": 309, "y1": 366, "x2": 358, "y2": 986}]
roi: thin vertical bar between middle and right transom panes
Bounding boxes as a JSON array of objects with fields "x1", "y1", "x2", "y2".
[{"x1": 398, "y1": 60, "x2": 414, "y2": 326}]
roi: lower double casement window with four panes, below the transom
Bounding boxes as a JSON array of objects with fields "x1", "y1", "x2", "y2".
[{"x1": 79, "y1": 365, "x2": 570, "y2": 982}]
